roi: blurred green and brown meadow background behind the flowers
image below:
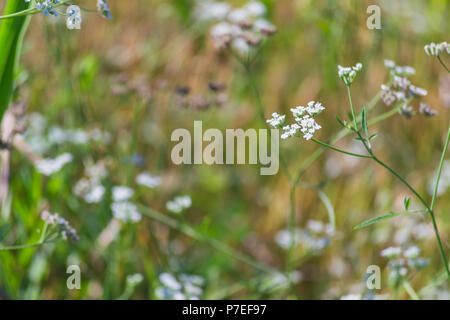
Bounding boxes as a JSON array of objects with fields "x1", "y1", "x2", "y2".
[{"x1": 0, "y1": 0, "x2": 450, "y2": 299}]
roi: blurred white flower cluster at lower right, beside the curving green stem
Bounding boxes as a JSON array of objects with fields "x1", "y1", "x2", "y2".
[{"x1": 381, "y1": 246, "x2": 430, "y2": 285}]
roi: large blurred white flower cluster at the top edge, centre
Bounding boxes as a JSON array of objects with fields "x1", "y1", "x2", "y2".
[{"x1": 207, "y1": 1, "x2": 276, "y2": 54}]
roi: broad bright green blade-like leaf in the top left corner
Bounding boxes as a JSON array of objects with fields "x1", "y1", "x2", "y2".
[{"x1": 0, "y1": 0, "x2": 30, "y2": 121}]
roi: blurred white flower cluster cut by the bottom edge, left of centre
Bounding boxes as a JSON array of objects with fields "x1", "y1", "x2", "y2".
[{"x1": 155, "y1": 272, "x2": 205, "y2": 300}]
